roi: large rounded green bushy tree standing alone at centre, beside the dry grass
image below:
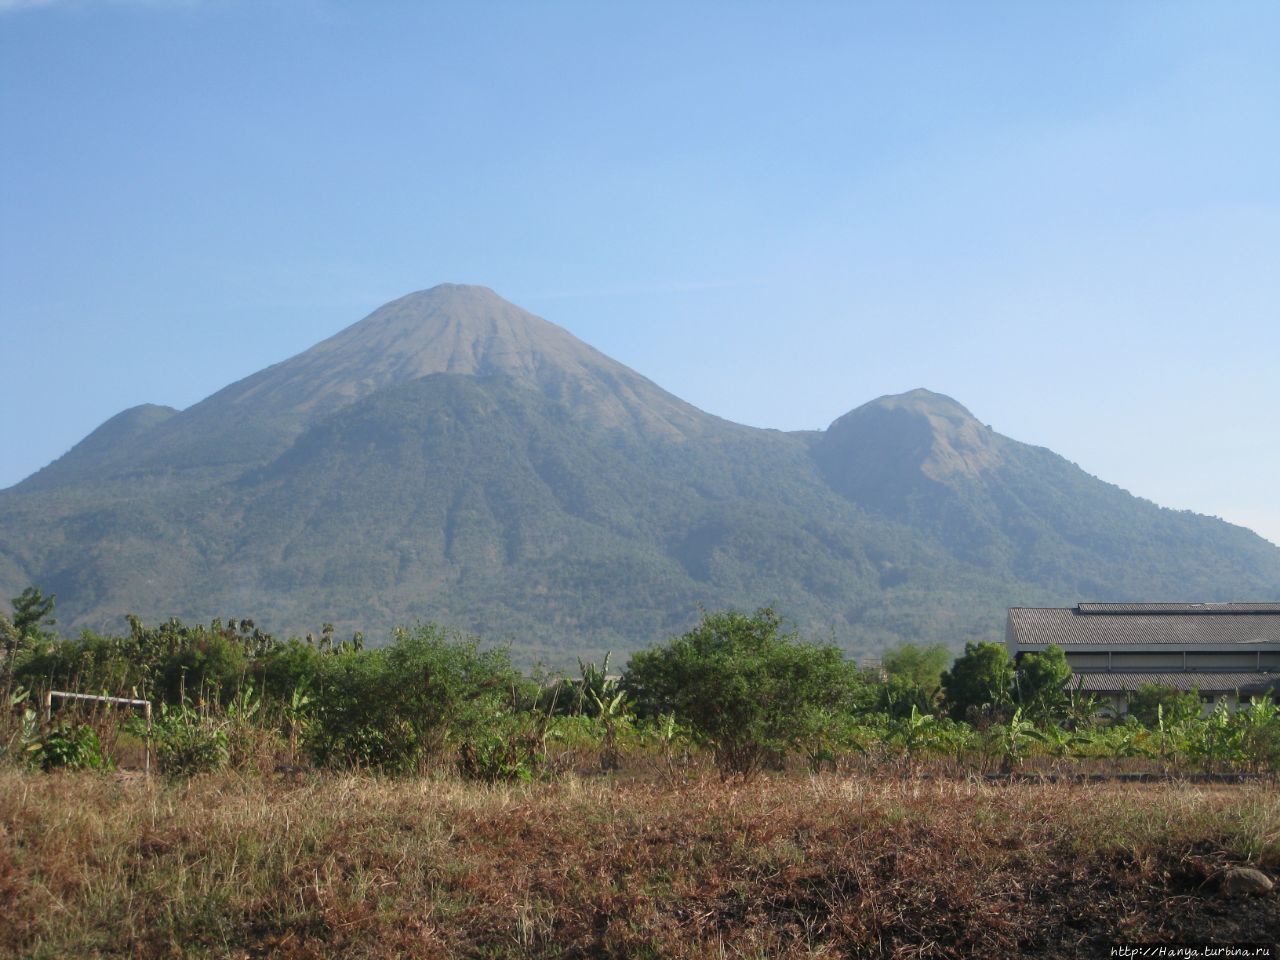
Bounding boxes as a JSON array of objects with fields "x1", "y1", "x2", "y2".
[{"x1": 622, "y1": 608, "x2": 858, "y2": 776}]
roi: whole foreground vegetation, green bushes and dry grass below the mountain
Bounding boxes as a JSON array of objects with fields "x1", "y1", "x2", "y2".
[{"x1": 0, "y1": 608, "x2": 1280, "y2": 957}]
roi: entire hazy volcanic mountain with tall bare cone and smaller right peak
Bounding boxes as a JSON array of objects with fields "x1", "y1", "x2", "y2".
[{"x1": 0, "y1": 285, "x2": 1280, "y2": 662}]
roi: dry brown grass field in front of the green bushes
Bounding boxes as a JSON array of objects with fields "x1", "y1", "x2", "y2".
[{"x1": 0, "y1": 769, "x2": 1280, "y2": 957}]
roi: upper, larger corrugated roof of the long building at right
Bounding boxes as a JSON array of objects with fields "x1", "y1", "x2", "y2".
[{"x1": 1009, "y1": 604, "x2": 1280, "y2": 646}]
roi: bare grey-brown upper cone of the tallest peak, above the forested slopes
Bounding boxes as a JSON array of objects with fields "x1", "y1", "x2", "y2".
[{"x1": 24, "y1": 283, "x2": 723, "y2": 486}]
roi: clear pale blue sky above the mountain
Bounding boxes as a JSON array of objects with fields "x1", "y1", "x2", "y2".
[{"x1": 0, "y1": 0, "x2": 1280, "y2": 541}]
